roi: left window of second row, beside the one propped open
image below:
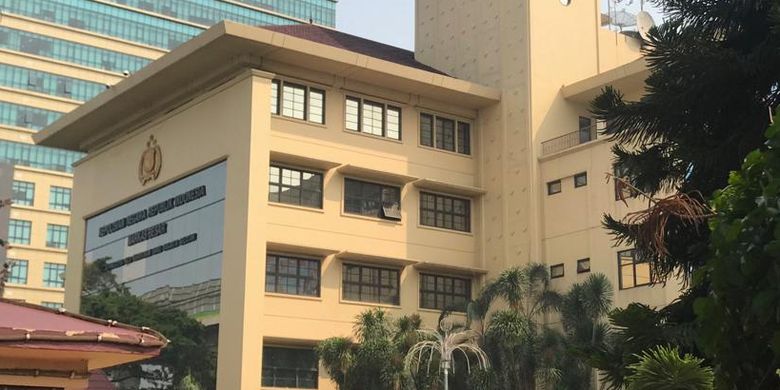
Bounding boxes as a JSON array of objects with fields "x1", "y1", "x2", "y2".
[{"x1": 268, "y1": 165, "x2": 322, "y2": 209}]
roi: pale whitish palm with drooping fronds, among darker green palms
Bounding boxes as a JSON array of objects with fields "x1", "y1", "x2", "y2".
[{"x1": 406, "y1": 319, "x2": 489, "y2": 390}]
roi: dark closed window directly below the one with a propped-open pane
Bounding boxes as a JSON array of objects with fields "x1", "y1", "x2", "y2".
[{"x1": 342, "y1": 264, "x2": 401, "y2": 305}]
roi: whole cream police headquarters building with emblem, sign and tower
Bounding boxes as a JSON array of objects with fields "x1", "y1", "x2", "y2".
[{"x1": 35, "y1": 0, "x2": 676, "y2": 389}]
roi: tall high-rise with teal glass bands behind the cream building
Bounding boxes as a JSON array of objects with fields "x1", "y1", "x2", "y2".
[{"x1": 0, "y1": 0, "x2": 335, "y2": 308}]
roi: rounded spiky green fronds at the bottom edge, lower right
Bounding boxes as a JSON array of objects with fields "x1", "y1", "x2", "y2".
[{"x1": 628, "y1": 346, "x2": 714, "y2": 390}]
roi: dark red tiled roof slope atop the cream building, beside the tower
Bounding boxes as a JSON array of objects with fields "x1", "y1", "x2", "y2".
[{"x1": 262, "y1": 24, "x2": 446, "y2": 75}]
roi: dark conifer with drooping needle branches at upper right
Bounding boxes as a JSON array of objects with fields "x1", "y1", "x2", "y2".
[{"x1": 593, "y1": 0, "x2": 780, "y2": 281}]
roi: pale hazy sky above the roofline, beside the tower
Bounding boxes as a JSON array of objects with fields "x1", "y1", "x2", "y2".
[{"x1": 336, "y1": 0, "x2": 660, "y2": 50}]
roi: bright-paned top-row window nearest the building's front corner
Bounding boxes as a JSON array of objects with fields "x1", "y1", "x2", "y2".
[{"x1": 271, "y1": 80, "x2": 325, "y2": 124}]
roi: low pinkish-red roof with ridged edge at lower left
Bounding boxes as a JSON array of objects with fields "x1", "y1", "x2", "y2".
[{"x1": 0, "y1": 299, "x2": 168, "y2": 356}]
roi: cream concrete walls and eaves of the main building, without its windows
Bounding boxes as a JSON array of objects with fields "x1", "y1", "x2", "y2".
[{"x1": 30, "y1": 0, "x2": 675, "y2": 389}]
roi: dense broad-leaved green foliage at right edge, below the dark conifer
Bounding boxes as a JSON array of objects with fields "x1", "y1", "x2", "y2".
[{"x1": 695, "y1": 111, "x2": 780, "y2": 389}]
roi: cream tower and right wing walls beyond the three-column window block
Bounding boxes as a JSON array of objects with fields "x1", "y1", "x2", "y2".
[{"x1": 416, "y1": 0, "x2": 679, "y2": 306}]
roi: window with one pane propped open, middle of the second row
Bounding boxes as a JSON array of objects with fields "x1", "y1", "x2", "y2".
[{"x1": 344, "y1": 179, "x2": 401, "y2": 221}]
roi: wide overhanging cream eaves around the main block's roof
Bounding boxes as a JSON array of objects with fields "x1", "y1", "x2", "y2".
[{"x1": 33, "y1": 21, "x2": 501, "y2": 152}]
